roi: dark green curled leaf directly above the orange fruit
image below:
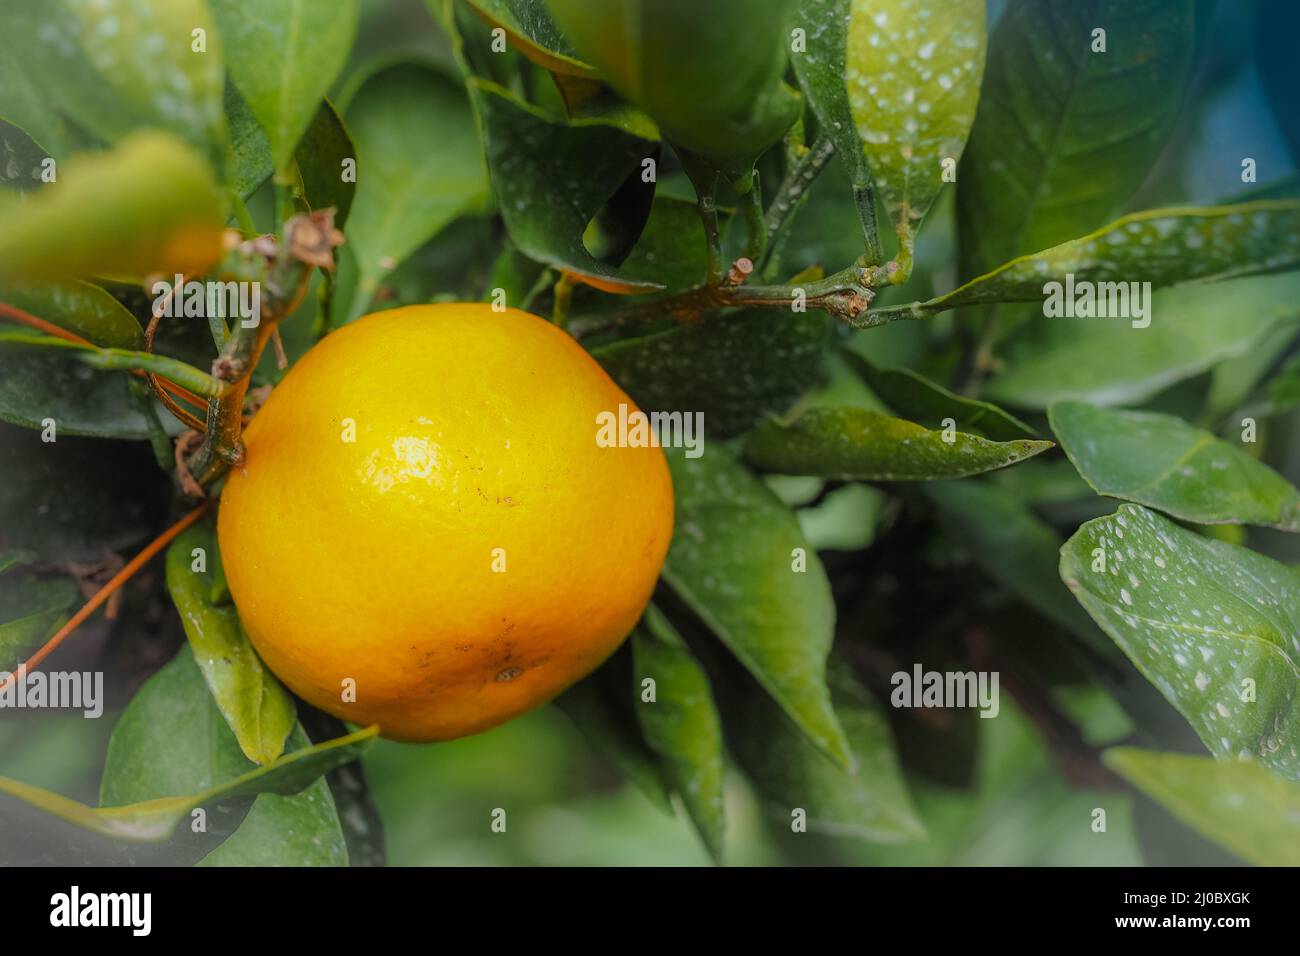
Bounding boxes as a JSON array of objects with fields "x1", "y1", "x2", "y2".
[{"x1": 471, "y1": 79, "x2": 663, "y2": 294}]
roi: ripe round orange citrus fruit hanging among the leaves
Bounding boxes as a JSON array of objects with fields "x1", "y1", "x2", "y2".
[{"x1": 218, "y1": 304, "x2": 672, "y2": 740}]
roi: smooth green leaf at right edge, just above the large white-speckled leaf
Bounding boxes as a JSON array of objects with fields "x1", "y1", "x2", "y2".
[{"x1": 1049, "y1": 402, "x2": 1300, "y2": 531}]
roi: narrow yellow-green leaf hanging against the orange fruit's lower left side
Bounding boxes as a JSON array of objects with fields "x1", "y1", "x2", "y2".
[{"x1": 166, "y1": 525, "x2": 296, "y2": 763}]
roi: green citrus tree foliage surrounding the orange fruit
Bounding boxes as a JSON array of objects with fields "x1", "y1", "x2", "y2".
[{"x1": 0, "y1": 0, "x2": 1300, "y2": 865}]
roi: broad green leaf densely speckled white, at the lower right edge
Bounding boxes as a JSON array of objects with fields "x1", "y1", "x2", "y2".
[{"x1": 1061, "y1": 505, "x2": 1300, "y2": 780}]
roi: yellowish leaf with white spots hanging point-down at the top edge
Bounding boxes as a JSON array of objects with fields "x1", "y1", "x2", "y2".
[{"x1": 845, "y1": 0, "x2": 987, "y2": 265}]
